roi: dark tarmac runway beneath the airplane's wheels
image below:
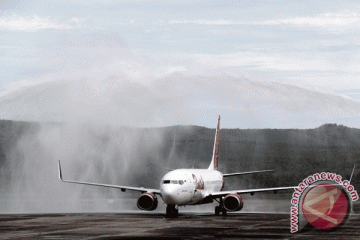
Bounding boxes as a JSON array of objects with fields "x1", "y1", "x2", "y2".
[{"x1": 0, "y1": 211, "x2": 360, "y2": 239}]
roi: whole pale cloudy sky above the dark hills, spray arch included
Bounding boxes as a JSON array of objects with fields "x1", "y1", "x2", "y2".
[{"x1": 0, "y1": 0, "x2": 360, "y2": 128}]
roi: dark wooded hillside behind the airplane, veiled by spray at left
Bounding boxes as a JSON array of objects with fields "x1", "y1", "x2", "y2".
[{"x1": 0, "y1": 120, "x2": 360, "y2": 193}]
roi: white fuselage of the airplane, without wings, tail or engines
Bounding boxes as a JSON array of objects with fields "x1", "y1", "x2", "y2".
[{"x1": 160, "y1": 169, "x2": 224, "y2": 206}]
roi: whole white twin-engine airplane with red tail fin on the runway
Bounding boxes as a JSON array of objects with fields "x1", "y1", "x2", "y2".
[{"x1": 59, "y1": 116, "x2": 294, "y2": 217}]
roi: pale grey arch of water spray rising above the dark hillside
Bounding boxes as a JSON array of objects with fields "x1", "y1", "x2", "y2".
[{"x1": 0, "y1": 72, "x2": 360, "y2": 129}]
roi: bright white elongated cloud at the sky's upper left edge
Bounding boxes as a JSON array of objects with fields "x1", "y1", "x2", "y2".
[{"x1": 0, "y1": 13, "x2": 83, "y2": 32}]
